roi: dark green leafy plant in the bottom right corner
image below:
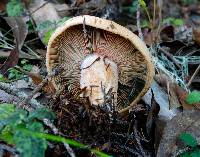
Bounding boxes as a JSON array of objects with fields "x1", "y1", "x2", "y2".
[{"x1": 179, "y1": 133, "x2": 200, "y2": 157}]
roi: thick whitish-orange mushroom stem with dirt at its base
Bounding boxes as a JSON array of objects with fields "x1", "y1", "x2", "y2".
[{"x1": 80, "y1": 54, "x2": 118, "y2": 110}]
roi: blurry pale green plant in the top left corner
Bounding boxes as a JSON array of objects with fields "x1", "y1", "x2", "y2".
[{"x1": 6, "y1": 0, "x2": 23, "y2": 16}]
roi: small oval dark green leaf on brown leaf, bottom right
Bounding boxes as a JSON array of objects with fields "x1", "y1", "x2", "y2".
[{"x1": 179, "y1": 133, "x2": 198, "y2": 147}]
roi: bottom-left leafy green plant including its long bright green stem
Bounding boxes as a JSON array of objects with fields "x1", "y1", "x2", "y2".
[{"x1": 0, "y1": 104, "x2": 109, "y2": 157}]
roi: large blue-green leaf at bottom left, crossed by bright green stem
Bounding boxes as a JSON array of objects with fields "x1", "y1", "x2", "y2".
[{"x1": 14, "y1": 122, "x2": 47, "y2": 157}]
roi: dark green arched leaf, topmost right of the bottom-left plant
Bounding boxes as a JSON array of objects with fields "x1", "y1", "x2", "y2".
[{"x1": 28, "y1": 108, "x2": 55, "y2": 121}]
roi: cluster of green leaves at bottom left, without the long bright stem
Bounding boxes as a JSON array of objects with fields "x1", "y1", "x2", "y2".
[{"x1": 0, "y1": 104, "x2": 55, "y2": 157}]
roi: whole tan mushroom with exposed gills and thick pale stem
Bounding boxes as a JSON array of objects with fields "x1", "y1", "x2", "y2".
[{"x1": 46, "y1": 15, "x2": 154, "y2": 113}]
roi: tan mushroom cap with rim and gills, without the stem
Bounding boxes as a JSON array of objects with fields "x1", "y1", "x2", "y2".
[{"x1": 46, "y1": 15, "x2": 154, "y2": 113}]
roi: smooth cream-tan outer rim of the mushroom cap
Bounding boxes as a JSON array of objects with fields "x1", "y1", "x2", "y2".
[{"x1": 46, "y1": 15, "x2": 155, "y2": 113}]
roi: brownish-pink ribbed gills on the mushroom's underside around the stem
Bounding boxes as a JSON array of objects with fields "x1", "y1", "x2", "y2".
[{"x1": 48, "y1": 25, "x2": 147, "y2": 110}]
